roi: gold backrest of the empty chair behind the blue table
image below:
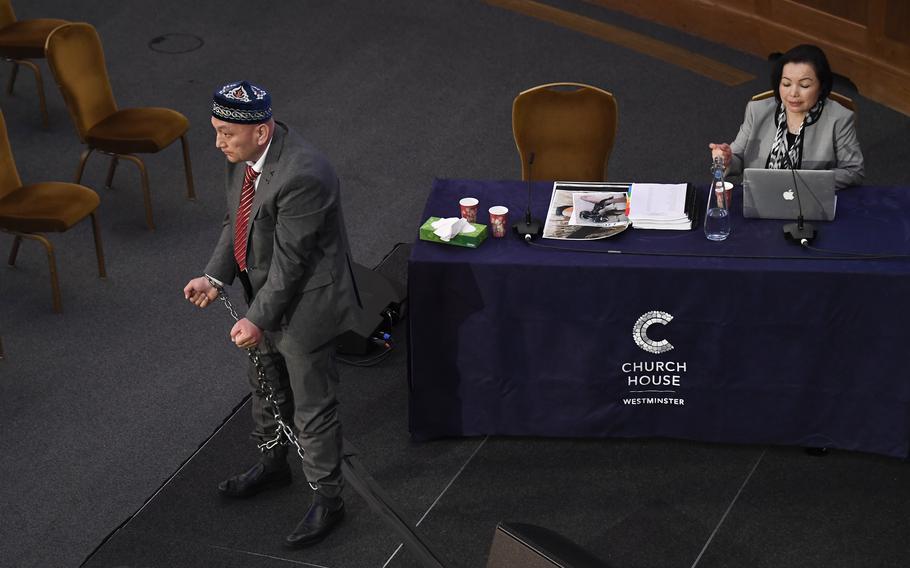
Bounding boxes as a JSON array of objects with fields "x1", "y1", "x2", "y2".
[{"x1": 512, "y1": 83, "x2": 617, "y2": 181}]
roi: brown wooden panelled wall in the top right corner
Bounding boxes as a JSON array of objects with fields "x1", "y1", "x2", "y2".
[{"x1": 588, "y1": 0, "x2": 910, "y2": 115}]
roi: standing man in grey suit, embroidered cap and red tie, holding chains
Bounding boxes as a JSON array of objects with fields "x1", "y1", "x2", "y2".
[{"x1": 184, "y1": 81, "x2": 360, "y2": 547}]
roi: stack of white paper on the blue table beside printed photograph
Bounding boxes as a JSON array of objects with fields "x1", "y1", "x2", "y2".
[{"x1": 629, "y1": 183, "x2": 696, "y2": 230}]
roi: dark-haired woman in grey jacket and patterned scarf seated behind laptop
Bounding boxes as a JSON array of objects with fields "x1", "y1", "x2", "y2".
[{"x1": 708, "y1": 45, "x2": 865, "y2": 189}]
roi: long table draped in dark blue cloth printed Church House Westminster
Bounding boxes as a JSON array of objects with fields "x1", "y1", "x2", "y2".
[{"x1": 408, "y1": 179, "x2": 910, "y2": 458}]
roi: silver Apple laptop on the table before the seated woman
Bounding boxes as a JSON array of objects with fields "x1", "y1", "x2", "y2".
[{"x1": 743, "y1": 168, "x2": 837, "y2": 221}]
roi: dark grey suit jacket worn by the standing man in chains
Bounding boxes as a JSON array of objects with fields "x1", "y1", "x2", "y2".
[{"x1": 205, "y1": 122, "x2": 361, "y2": 353}]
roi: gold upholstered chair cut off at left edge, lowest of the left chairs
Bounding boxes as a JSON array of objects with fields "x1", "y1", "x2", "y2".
[{"x1": 0, "y1": 108, "x2": 106, "y2": 312}]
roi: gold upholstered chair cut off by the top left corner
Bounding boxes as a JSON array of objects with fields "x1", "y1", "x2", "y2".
[{"x1": 0, "y1": 0, "x2": 66, "y2": 128}]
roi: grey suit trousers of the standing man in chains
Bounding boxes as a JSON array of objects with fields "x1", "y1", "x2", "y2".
[{"x1": 248, "y1": 331, "x2": 344, "y2": 498}]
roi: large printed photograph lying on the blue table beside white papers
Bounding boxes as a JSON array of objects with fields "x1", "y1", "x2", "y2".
[{"x1": 543, "y1": 181, "x2": 629, "y2": 240}]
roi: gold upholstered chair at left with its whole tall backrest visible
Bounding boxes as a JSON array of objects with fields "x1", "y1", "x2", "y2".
[{"x1": 45, "y1": 23, "x2": 196, "y2": 229}]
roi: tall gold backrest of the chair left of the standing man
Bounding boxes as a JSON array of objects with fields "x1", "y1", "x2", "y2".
[{"x1": 44, "y1": 23, "x2": 117, "y2": 142}]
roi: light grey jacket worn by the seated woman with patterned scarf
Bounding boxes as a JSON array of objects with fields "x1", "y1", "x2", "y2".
[{"x1": 727, "y1": 98, "x2": 865, "y2": 189}]
